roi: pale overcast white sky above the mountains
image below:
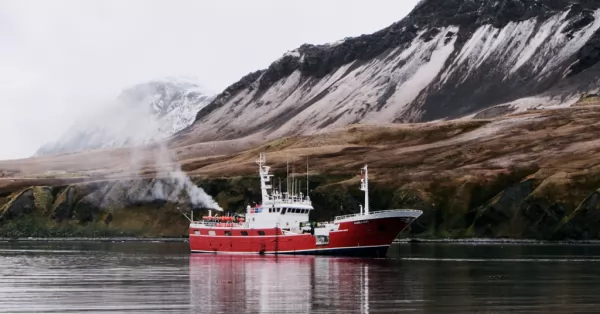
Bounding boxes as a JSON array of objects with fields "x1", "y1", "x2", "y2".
[{"x1": 0, "y1": 0, "x2": 417, "y2": 160}]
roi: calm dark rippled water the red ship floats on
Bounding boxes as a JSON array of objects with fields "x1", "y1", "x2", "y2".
[{"x1": 0, "y1": 242, "x2": 600, "y2": 313}]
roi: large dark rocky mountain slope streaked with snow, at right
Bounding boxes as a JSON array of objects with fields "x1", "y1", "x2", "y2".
[{"x1": 181, "y1": 0, "x2": 600, "y2": 141}]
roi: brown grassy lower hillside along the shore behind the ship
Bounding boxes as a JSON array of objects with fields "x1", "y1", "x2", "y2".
[{"x1": 0, "y1": 102, "x2": 600, "y2": 239}]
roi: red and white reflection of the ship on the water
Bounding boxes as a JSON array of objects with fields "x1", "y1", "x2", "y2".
[{"x1": 190, "y1": 254, "x2": 408, "y2": 313}]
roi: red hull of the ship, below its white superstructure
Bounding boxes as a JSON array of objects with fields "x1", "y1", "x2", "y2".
[{"x1": 190, "y1": 217, "x2": 413, "y2": 257}]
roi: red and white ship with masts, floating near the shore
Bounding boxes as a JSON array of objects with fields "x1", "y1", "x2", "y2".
[{"x1": 189, "y1": 153, "x2": 423, "y2": 257}]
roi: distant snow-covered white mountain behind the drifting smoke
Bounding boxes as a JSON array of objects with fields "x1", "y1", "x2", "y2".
[{"x1": 36, "y1": 78, "x2": 214, "y2": 156}]
